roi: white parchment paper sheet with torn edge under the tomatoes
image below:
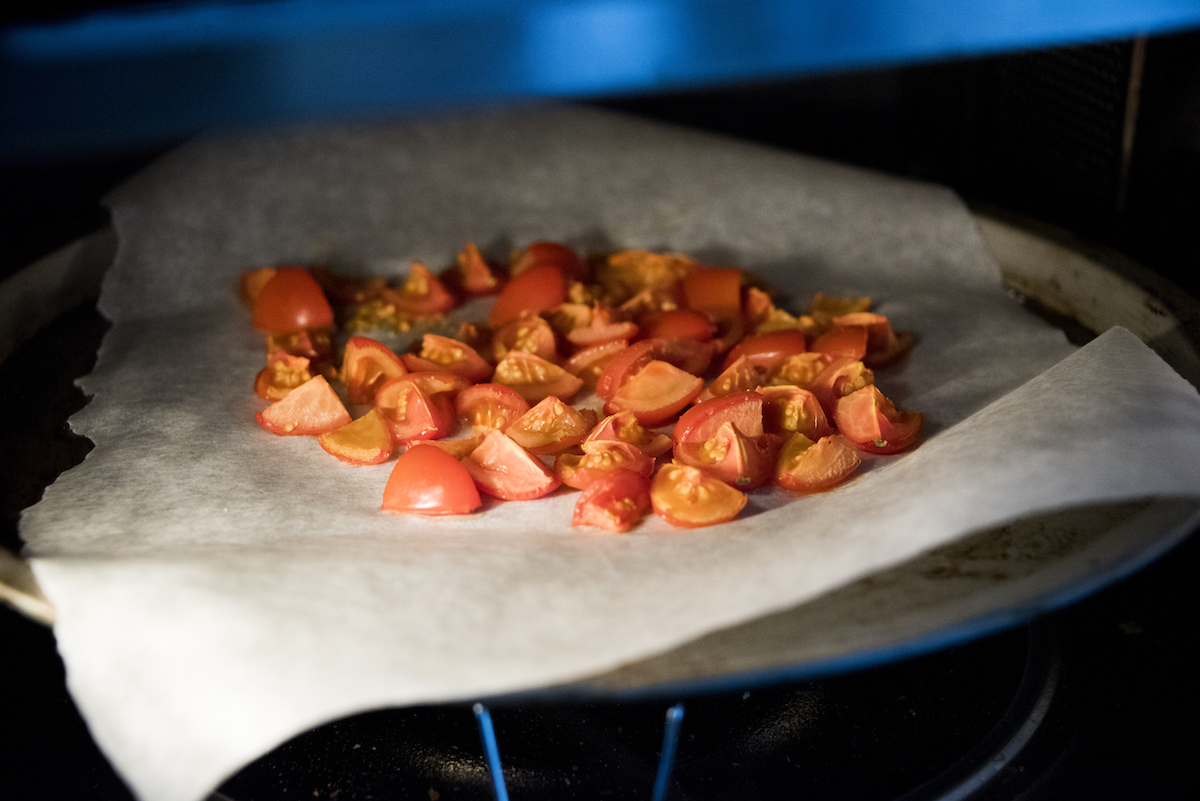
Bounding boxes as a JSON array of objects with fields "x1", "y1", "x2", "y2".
[{"x1": 22, "y1": 109, "x2": 1200, "y2": 801}]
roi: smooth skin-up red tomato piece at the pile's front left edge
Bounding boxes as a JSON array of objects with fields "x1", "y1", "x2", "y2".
[{"x1": 380, "y1": 445, "x2": 482, "y2": 514}]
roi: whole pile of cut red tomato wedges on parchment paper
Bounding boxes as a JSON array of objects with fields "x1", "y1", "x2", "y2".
[{"x1": 239, "y1": 242, "x2": 924, "y2": 531}]
